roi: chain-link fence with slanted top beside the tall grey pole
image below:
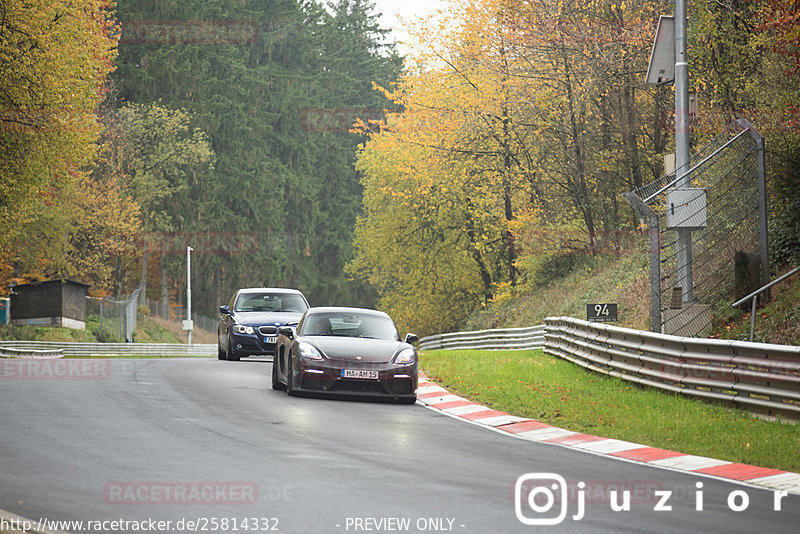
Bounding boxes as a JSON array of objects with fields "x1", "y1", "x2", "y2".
[{"x1": 625, "y1": 121, "x2": 769, "y2": 336}]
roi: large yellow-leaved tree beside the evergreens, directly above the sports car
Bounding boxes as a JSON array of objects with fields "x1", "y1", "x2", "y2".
[{"x1": 351, "y1": 0, "x2": 536, "y2": 332}]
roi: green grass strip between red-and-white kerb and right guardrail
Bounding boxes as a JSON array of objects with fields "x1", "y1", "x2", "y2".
[{"x1": 420, "y1": 350, "x2": 800, "y2": 472}]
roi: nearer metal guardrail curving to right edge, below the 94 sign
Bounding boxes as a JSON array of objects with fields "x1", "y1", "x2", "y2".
[{"x1": 544, "y1": 317, "x2": 800, "y2": 419}]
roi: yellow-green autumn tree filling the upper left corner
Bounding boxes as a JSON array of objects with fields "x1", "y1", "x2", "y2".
[{"x1": 0, "y1": 0, "x2": 117, "y2": 287}]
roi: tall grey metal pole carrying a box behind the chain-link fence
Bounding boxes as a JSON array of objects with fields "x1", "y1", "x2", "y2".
[{"x1": 675, "y1": 0, "x2": 693, "y2": 302}]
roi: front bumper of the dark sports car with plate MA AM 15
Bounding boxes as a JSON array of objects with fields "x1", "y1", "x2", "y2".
[{"x1": 290, "y1": 358, "x2": 418, "y2": 400}]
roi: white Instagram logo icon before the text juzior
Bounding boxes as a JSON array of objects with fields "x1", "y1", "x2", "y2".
[{"x1": 514, "y1": 473, "x2": 567, "y2": 525}]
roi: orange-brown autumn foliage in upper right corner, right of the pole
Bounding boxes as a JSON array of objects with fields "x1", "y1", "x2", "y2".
[{"x1": 689, "y1": 0, "x2": 800, "y2": 265}]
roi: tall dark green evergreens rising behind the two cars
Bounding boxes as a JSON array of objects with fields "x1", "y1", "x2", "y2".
[{"x1": 114, "y1": 0, "x2": 402, "y2": 315}]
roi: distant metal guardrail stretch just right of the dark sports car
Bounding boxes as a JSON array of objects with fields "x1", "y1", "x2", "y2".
[{"x1": 419, "y1": 325, "x2": 545, "y2": 350}]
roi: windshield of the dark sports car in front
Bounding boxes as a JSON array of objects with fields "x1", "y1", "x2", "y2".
[{"x1": 300, "y1": 312, "x2": 400, "y2": 341}]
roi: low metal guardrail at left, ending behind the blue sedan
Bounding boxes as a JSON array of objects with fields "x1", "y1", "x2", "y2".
[{"x1": 0, "y1": 341, "x2": 217, "y2": 358}]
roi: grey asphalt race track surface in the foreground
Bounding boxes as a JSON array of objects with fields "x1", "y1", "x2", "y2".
[{"x1": 0, "y1": 359, "x2": 800, "y2": 534}]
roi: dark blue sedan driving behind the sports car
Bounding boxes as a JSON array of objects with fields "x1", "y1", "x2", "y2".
[{"x1": 217, "y1": 287, "x2": 308, "y2": 361}]
